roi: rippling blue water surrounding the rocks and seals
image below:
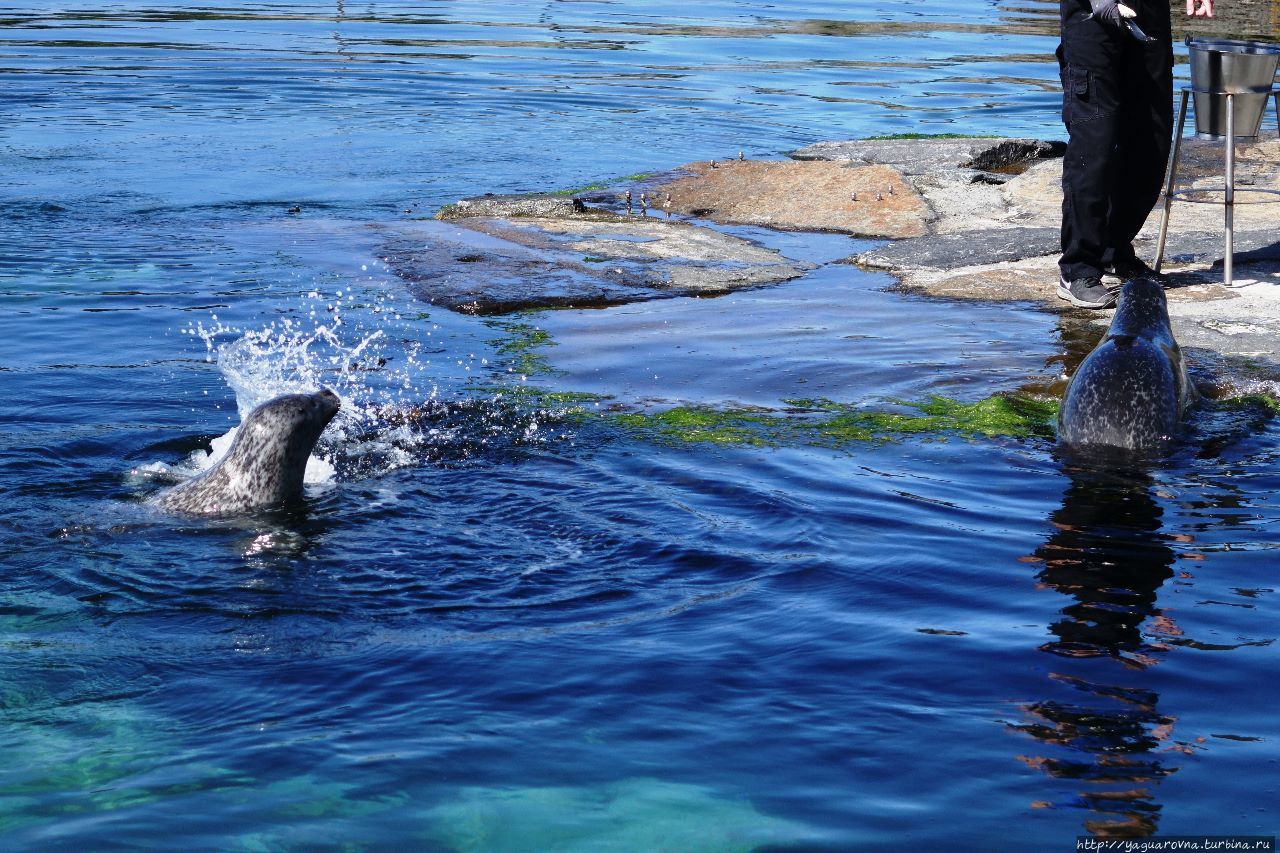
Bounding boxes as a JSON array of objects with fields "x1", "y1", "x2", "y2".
[{"x1": 0, "y1": 0, "x2": 1280, "y2": 850}]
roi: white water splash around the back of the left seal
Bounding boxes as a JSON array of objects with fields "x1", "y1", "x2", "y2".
[{"x1": 162, "y1": 289, "x2": 578, "y2": 485}]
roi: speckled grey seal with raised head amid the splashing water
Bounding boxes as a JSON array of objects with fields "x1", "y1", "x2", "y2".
[{"x1": 156, "y1": 388, "x2": 339, "y2": 515}]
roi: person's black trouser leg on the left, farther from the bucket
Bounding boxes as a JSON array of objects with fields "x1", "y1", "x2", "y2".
[{"x1": 1057, "y1": 0, "x2": 1129, "y2": 282}]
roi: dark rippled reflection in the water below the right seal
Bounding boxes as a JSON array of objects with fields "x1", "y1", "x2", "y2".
[{"x1": 1015, "y1": 462, "x2": 1178, "y2": 838}]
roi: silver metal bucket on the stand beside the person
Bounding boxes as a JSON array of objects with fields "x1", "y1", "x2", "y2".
[{"x1": 1187, "y1": 38, "x2": 1280, "y2": 138}]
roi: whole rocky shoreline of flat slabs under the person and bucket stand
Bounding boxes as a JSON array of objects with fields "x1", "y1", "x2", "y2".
[{"x1": 404, "y1": 137, "x2": 1280, "y2": 374}]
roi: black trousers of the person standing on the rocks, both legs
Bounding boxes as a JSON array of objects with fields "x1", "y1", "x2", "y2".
[{"x1": 1057, "y1": 0, "x2": 1174, "y2": 282}]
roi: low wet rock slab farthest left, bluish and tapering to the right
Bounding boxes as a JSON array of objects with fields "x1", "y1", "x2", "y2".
[{"x1": 387, "y1": 211, "x2": 805, "y2": 314}]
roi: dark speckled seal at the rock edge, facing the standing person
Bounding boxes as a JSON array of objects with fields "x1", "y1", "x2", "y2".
[{"x1": 1059, "y1": 278, "x2": 1199, "y2": 456}]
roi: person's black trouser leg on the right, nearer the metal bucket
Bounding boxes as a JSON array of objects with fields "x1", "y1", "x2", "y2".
[{"x1": 1103, "y1": 4, "x2": 1174, "y2": 265}]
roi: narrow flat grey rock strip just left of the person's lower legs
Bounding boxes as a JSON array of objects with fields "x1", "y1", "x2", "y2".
[{"x1": 854, "y1": 228, "x2": 1061, "y2": 270}]
